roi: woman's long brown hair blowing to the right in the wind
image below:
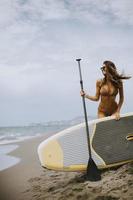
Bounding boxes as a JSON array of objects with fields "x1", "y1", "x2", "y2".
[{"x1": 103, "y1": 60, "x2": 131, "y2": 88}]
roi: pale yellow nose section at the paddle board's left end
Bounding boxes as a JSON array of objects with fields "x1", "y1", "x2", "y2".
[{"x1": 38, "y1": 140, "x2": 63, "y2": 170}]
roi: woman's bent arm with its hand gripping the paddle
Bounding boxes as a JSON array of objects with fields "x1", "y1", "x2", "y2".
[{"x1": 80, "y1": 80, "x2": 101, "y2": 101}]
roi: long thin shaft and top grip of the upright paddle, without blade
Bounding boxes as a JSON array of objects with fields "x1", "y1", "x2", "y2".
[{"x1": 76, "y1": 59, "x2": 92, "y2": 158}]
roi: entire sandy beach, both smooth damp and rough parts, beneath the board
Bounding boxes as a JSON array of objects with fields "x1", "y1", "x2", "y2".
[{"x1": 0, "y1": 136, "x2": 133, "y2": 200}]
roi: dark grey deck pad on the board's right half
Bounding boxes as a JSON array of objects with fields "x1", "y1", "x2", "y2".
[{"x1": 92, "y1": 116, "x2": 133, "y2": 164}]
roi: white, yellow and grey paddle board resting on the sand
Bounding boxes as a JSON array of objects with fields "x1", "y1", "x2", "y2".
[{"x1": 38, "y1": 113, "x2": 133, "y2": 171}]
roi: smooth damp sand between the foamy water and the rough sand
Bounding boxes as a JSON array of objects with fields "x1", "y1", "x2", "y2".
[{"x1": 0, "y1": 135, "x2": 48, "y2": 200}]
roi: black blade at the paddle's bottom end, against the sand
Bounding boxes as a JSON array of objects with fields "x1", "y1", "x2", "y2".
[{"x1": 86, "y1": 158, "x2": 101, "y2": 181}]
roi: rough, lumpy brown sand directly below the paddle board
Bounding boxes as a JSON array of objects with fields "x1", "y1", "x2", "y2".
[{"x1": 25, "y1": 164, "x2": 133, "y2": 200}]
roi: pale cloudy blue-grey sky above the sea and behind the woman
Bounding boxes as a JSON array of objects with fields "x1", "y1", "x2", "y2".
[{"x1": 0, "y1": 0, "x2": 133, "y2": 126}]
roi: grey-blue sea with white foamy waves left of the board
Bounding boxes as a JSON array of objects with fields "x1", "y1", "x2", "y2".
[{"x1": 0, "y1": 117, "x2": 94, "y2": 171}]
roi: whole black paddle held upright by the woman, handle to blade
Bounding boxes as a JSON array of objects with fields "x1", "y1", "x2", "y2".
[{"x1": 76, "y1": 59, "x2": 101, "y2": 181}]
